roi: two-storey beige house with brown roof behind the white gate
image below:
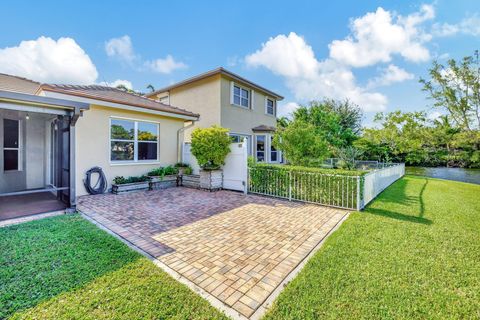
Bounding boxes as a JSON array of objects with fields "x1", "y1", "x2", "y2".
[{"x1": 147, "y1": 68, "x2": 283, "y2": 163}]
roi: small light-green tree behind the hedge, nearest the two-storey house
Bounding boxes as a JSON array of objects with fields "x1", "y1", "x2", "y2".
[{"x1": 273, "y1": 121, "x2": 330, "y2": 166}]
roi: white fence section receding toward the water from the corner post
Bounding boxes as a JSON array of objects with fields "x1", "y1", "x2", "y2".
[{"x1": 361, "y1": 163, "x2": 405, "y2": 209}]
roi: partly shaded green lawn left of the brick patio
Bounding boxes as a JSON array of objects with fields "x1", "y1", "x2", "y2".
[{"x1": 0, "y1": 215, "x2": 225, "y2": 319}]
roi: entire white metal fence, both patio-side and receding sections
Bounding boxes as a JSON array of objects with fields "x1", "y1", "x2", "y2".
[{"x1": 248, "y1": 164, "x2": 405, "y2": 210}]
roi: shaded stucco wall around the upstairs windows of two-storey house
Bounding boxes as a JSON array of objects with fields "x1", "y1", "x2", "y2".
[{"x1": 221, "y1": 77, "x2": 276, "y2": 135}]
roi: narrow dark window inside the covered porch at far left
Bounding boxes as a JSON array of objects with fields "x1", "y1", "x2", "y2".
[{"x1": 3, "y1": 119, "x2": 22, "y2": 171}]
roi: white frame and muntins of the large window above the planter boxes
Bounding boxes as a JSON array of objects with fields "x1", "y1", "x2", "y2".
[{"x1": 108, "y1": 117, "x2": 160, "y2": 165}]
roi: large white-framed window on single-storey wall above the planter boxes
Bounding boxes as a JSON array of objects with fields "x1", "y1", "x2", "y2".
[{"x1": 110, "y1": 118, "x2": 159, "y2": 163}]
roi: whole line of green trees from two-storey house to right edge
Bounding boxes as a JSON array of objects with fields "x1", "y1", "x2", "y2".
[{"x1": 274, "y1": 52, "x2": 480, "y2": 168}]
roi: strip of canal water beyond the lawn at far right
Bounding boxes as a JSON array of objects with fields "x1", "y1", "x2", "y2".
[{"x1": 405, "y1": 167, "x2": 480, "y2": 184}]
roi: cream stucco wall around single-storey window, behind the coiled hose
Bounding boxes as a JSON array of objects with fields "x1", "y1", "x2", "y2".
[{"x1": 75, "y1": 106, "x2": 184, "y2": 196}]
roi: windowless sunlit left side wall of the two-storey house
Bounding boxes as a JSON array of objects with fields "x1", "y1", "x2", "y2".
[{"x1": 157, "y1": 75, "x2": 221, "y2": 141}]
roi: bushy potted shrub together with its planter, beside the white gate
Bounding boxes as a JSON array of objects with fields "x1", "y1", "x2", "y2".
[{"x1": 190, "y1": 126, "x2": 232, "y2": 190}]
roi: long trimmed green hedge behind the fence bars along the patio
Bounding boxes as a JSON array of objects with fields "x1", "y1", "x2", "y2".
[{"x1": 249, "y1": 164, "x2": 366, "y2": 209}]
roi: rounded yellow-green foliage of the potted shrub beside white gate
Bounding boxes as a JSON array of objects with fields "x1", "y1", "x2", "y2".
[{"x1": 191, "y1": 126, "x2": 232, "y2": 170}]
